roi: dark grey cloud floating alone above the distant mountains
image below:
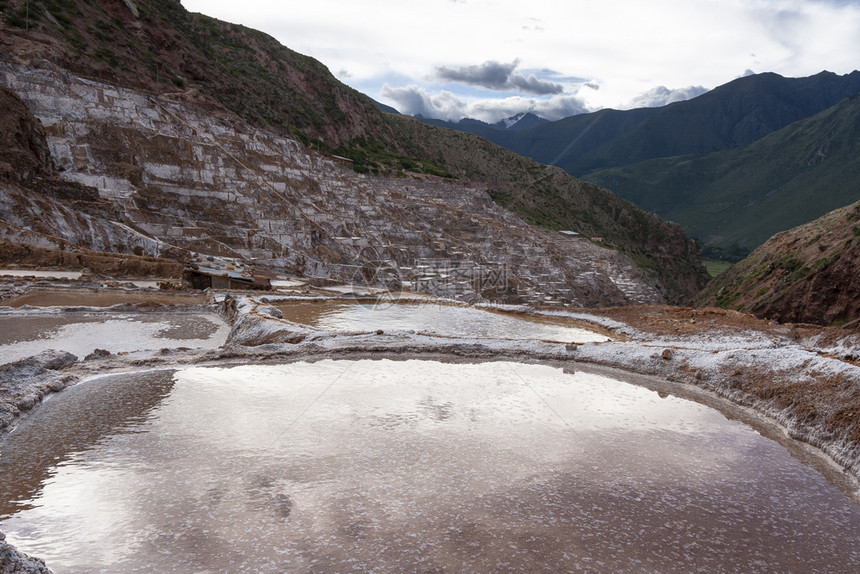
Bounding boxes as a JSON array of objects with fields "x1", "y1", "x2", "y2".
[{"x1": 436, "y1": 60, "x2": 564, "y2": 96}]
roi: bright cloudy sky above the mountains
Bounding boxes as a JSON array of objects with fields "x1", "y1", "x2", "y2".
[{"x1": 182, "y1": 0, "x2": 860, "y2": 122}]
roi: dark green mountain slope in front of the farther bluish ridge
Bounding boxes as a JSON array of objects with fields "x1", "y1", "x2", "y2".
[{"x1": 588, "y1": 95, "x2": 860, "y2": 260}]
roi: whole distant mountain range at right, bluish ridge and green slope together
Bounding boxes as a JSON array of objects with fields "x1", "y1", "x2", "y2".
[{"x1": 420, "y1": 71, "x2": 860, "y2": 260}]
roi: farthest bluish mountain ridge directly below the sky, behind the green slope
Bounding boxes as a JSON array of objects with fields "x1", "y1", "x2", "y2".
[{"x1": 422, "y1": 72, "x2": 860, "y2": 177}]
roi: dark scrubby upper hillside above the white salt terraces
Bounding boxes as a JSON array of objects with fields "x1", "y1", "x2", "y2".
[{"x1": 0, "y1": 0, "x2": 706, "y2": 299}]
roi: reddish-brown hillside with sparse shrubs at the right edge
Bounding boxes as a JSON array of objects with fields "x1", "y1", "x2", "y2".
[{"x1": 699, "y1": 202, "x2": 860, "y2": 325}]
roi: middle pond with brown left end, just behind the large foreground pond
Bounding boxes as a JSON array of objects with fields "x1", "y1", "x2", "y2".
[{"x1": 273, "y1": 301, "x2": 609, "y2": 343}]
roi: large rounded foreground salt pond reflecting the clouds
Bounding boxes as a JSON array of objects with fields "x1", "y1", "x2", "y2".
[{"x1": 0, "y1": 360, "x2": 860, "y2": 574}]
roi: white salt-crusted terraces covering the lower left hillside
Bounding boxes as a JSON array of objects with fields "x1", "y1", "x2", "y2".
[{"x1": 0, "y1": 64, "x2": 661, "y2": 306}]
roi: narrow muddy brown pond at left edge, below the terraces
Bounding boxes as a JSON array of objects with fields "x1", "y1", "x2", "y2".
[{"x1": 2, "y1": 289, "x2": 205, "y2": 307}]
